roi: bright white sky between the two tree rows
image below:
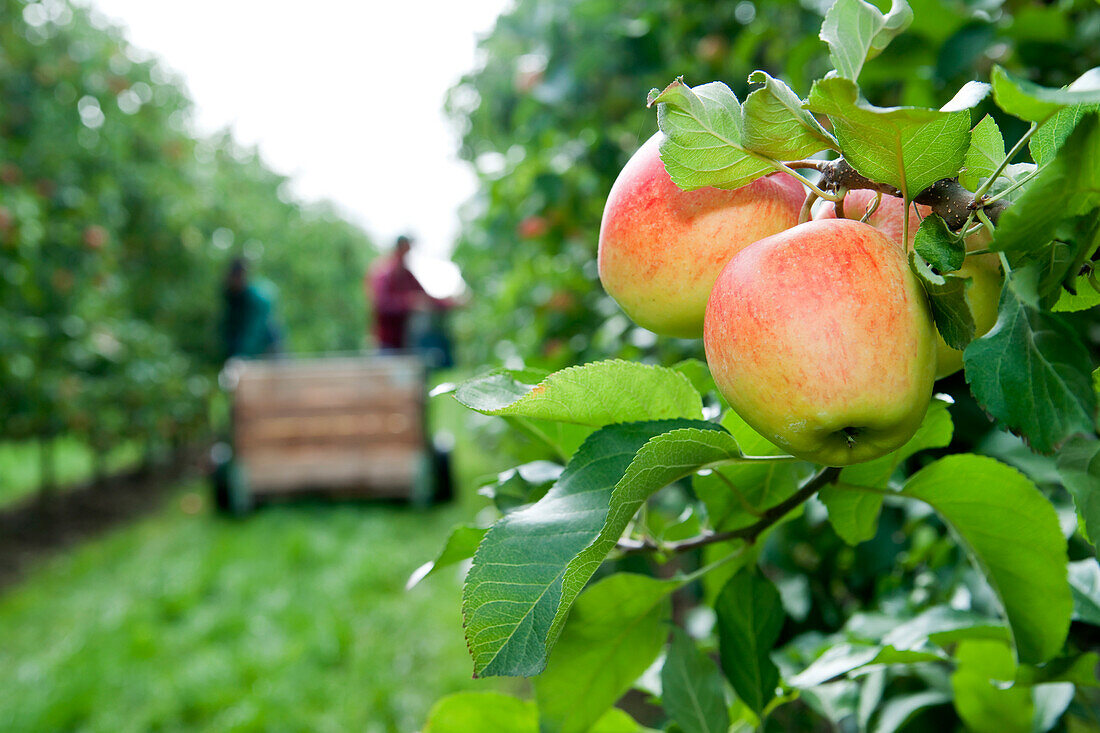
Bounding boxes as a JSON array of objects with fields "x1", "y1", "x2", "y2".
[{"x1": 85, "y1": 0, "x2": 508, "y2": 285}]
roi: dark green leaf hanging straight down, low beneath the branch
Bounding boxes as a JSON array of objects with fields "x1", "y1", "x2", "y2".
[{"x1": 714, "y1": 570, "x2": 784, "y2": 715}]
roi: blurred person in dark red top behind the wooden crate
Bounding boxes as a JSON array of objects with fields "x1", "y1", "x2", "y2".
[{"x1": 365, "y1": 234, "x2": 453, "y2": 349}]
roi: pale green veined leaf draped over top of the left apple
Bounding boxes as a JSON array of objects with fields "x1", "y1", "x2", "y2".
[{"x1": 649, "y1": 79, "x2": 776, "y2": 190}]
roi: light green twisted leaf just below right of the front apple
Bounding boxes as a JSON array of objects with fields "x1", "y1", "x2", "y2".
[{"x1": 817, "y1": 400, "x2": 954, "y2": 545}]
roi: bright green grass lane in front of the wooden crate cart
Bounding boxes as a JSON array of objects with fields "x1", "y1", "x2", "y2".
[{"x1": 0, "y1": 378, "x2": 521, "y2": 732}]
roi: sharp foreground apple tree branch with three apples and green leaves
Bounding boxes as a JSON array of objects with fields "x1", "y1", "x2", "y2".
[{"x1": 415, "y1": 0, "x2": 1100, "y2": 732}]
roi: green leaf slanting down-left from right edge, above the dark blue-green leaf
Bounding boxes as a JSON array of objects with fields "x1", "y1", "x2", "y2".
[{"x1": 991, "y1": 113, "x2": 1100, "y2": 252}]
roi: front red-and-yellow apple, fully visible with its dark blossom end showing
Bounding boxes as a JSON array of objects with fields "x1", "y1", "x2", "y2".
[{"x1": 703, "y1": 219, "x2": 936, "y2": 466}]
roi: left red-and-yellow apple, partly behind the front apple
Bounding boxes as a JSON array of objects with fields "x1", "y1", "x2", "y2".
[{"x1": 598, "y1": 132, "x2": 805, "y2": 338}]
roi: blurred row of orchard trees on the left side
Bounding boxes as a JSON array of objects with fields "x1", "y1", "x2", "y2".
[{"x1": 0, "y1": 0, "x2": 372, "y2": 490}]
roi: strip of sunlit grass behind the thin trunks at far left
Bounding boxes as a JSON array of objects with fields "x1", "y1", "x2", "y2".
[{"x1": 0, "y1": 436, "x2": 141, "y2": 506}]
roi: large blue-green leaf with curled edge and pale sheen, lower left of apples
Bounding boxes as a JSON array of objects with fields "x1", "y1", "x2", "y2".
[{"x1": 463, "y1": 420, "x2": 765, "y2": 676}]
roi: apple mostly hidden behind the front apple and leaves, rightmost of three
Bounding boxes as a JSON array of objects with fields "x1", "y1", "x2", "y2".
[{"x1": 816, "y1": 189, "x2": 1004, "y2": 379}]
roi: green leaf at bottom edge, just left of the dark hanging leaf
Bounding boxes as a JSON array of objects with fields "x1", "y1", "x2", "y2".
[{"x1": 661, "y1": 627, "x2": 729, "y2": 733}]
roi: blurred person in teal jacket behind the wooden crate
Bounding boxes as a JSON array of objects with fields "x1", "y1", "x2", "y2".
[{"x1": 222, "y1": 258, "x2": 278, "y2": 359}]
